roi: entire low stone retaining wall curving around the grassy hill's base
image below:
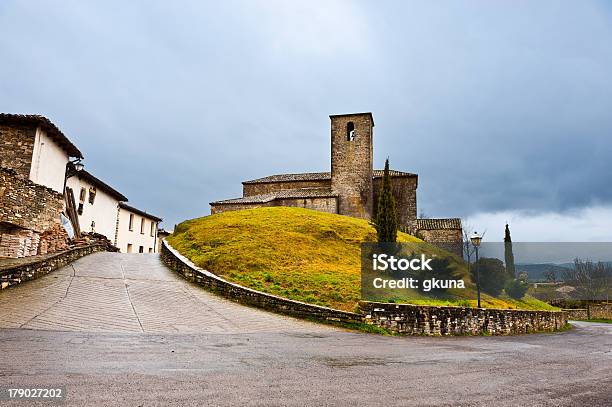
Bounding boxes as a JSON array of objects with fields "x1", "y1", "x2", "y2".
[{"x1": 160, "y1": 240, "x2": 567, "y2": 335}]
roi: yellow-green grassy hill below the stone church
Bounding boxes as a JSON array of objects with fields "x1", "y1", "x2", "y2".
[{"x1": 168, "y1": 207, "x2": 552, "y2": 311}]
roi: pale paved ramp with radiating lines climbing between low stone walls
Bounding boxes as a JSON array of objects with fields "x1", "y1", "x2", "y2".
[{"x1": 0, "y1": 253, "x2": 331, "y2": 333}]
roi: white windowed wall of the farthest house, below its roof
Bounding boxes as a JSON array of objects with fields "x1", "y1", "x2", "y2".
[{"x1": 116, "y1": 208, "x2": 158, "y2": 253}]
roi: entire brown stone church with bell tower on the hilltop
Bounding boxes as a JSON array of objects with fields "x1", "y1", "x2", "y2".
[{"x1": 210, "y1": 113, "x2": 462, "y2": 250}]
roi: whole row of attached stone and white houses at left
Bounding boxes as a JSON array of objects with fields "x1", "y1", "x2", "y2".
[{"x1": 0, "y1": 113, "x2": 161, "y2": 257}]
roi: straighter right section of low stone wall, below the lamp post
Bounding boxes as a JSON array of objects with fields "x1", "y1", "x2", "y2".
[{"x1": 360, "y1": 301, "x2": 567, "y2": 335}]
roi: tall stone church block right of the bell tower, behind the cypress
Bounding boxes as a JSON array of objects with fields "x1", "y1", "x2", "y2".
[{"x1": 373, "y1": 177, "x2": 417, "y2": 234}]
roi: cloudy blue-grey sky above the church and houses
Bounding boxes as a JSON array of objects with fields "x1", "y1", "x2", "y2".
[{"x1": 0, "y1": 0, "x2": 612, "y2": 241}]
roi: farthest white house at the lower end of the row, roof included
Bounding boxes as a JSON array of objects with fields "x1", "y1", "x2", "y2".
[{"x1": 114, "y1": 202, "x2": 162, "y2": 253}]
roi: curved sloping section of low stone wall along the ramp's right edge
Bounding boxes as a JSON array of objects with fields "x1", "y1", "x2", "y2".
[{"x1": 160, "y1": 239, "x2": 362, "y2": 323}]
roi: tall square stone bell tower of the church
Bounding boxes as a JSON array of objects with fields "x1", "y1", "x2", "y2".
[{"x1": 331, "y1": 114, "x2": 374, "y2": 219}]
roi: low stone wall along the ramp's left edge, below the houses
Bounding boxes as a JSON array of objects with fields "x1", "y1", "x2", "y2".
[{"x1": 0, "y1": 243, "x2": 108, "y2": 289}]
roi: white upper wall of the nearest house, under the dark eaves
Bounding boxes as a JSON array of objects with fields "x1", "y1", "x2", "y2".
[{"x1": 30, "y1": 127, "x2": 70, "y2": 193}]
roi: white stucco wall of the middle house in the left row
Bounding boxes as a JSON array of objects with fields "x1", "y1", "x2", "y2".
[{"x1": 66, "y1": 176, "x2": 119, "y2": 242}]
